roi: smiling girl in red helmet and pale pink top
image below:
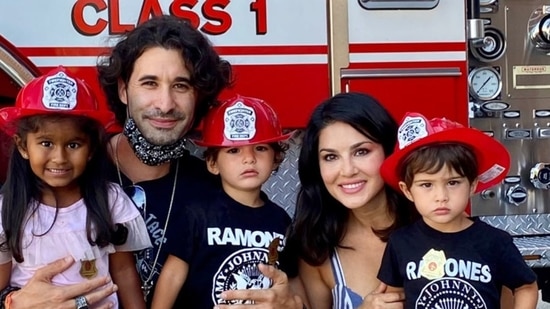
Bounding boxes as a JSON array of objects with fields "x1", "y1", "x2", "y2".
[{"x1": 0, "y1": 67, "x2": 151, "y2": 308}]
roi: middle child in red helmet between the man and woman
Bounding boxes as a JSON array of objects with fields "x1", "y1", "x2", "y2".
[{"x1": 152, "y1": 96, "x2": 296, "y2": 309}]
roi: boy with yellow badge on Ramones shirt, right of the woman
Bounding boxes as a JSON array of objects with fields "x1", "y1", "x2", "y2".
[{"x1": 378, "y1": 113, "x2": 538, "y2": 309}]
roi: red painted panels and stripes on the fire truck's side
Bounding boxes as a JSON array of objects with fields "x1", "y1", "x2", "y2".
[{"x1": 20, "y1": 42, "x2": 468, "y2": 128}]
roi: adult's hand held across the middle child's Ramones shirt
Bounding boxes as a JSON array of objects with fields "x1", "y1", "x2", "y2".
[{"x1": 214, "y1": 264, "x2": 304, "y2": 309}]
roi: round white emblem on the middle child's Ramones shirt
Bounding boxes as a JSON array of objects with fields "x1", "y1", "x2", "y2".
[{"x1": 212, "y1": 248, "x2": 271, "y2": 304}]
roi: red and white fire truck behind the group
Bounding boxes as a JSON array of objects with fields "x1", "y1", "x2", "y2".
[{"x1": 0, "y1": 0, "x2": 550, "y2": 300}]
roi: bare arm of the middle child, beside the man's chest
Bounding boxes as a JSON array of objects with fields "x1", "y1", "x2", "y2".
[{"x1": 151, "y1": 255, "x2": 189, "y2": 309}]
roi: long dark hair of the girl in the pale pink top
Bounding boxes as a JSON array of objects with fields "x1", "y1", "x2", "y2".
[{"x1": 0, "y1": 114, "x2": 126, "y2": 263}]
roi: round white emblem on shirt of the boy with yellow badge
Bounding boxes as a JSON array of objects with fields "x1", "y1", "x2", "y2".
[{"x1": 415, "y1": 278, "x2": 487, "y2": 309}]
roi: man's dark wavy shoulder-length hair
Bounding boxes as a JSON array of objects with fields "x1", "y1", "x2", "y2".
[{"x1": 97, "y1": 15, "x2": 232, "y2": 128}]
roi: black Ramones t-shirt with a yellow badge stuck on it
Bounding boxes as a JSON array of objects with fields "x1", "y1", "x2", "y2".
[{"x1": 378, "y1": 220, "x2": 536, "y2": 309}]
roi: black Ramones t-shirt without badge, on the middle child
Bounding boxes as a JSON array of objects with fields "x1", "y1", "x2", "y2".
[{"x1": 166, "y1": 189, "x2": 290, "y2": 309}]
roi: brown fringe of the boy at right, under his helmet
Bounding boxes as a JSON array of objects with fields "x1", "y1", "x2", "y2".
[{"x1": 397, "y1": 143, "x2": 478, "y2": 188}]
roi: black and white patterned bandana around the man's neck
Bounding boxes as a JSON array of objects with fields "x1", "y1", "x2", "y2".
[{"x1": 123, "y1": 118, "x2": 186, "y2": 166}]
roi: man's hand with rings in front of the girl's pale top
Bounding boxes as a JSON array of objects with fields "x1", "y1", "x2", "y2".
[{"x1": 10, "y1": 257, "x2": 118, "y2": 309}]
